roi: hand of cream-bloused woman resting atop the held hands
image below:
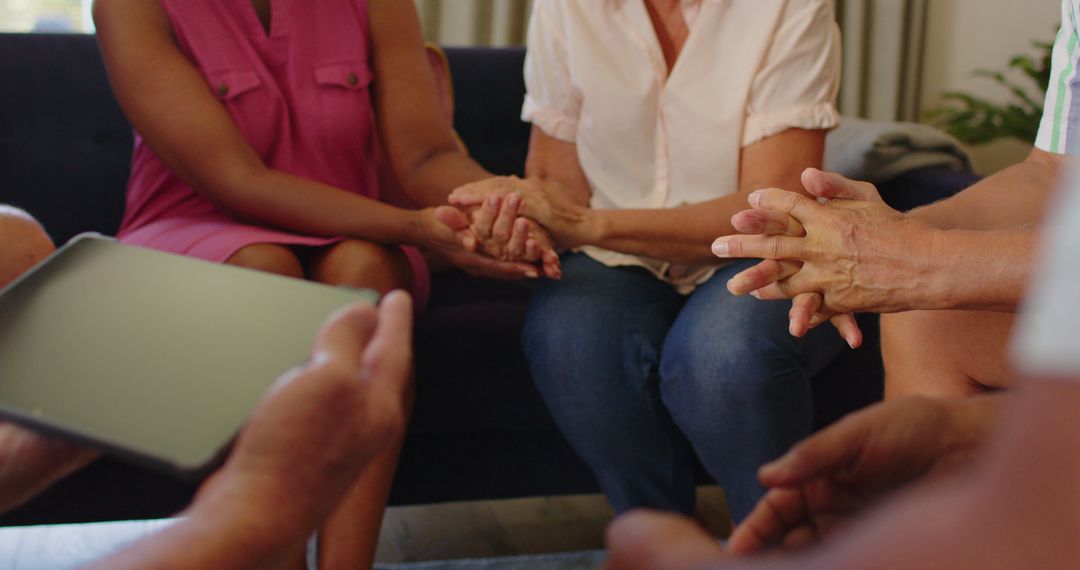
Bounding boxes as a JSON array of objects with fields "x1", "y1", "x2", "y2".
[{"x1": 449, "y1": 176, "x2": 596, "y2": 248}]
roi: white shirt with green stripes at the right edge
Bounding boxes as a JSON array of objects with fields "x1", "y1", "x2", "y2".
[{"x1": 1035, "y1": 0, "x2": 1080, "y2": 154}]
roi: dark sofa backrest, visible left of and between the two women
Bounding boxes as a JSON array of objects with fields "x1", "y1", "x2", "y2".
[{"x1": 0, "y1": 33, "x2": 529, "y2": 244}]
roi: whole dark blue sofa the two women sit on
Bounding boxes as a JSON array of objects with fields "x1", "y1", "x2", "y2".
[{"x1": 0, "y1": 35, "x2": 973, "y2": 525}]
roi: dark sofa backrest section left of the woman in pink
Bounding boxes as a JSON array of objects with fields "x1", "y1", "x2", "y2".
[{"x1": 0, "y1": 33, "x2": 132, "y2": 243}]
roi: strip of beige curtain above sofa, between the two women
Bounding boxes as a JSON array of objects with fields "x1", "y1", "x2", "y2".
[{"x1": 416, "y1": 0, "x2": 531, "y2": 45}]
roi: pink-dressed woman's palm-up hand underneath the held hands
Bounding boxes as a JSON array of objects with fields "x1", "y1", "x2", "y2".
[{"x1": 417, "y1": 206, "x2": 540, "y2": 280}]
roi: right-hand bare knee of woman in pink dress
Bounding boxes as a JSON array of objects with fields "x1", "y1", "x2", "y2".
[{"x1": 310, "y1": 240, "x2": 411, "y2": 293}]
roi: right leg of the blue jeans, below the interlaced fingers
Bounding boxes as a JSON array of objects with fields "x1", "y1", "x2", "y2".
[{"x1": 660, "y1": 260, "x2": 845, "y2": 518}]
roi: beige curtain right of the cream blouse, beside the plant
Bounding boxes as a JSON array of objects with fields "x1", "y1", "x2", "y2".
[{"x1": 836, "y1": 0, "x2": 929, "y2": 121}]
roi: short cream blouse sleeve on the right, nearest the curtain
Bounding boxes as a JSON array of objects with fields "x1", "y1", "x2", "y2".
[{"x1": 742, "y1": 0, "x2": 840, "y2": 146}]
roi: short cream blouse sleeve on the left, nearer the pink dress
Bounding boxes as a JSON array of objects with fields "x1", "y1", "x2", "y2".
[{"x1": 522, "y1": 0, "x2": 581, "y2": 143}]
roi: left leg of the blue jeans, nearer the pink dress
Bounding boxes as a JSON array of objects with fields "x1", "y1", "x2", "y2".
[{"x1": 523, "y1": 254, "x2": 693, "y2": 513}]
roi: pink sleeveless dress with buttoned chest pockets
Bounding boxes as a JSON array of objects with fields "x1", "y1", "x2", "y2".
[{"x1": 117, "y1": 0, "x2": 430, "y2": 307}]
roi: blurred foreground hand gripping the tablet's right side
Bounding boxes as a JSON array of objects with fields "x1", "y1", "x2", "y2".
[{"x1": 192, "y1": 291, "x2": 413, "y2": 541}]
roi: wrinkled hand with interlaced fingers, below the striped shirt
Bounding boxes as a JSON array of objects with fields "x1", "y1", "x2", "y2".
[{"x1": 713, "y1": 168, "x2": 935, "y2": 315}]
